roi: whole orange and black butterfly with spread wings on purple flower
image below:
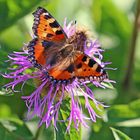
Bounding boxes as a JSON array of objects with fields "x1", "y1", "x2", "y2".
[{"x1": 27, "y1": 7, "x2": 107, "y2": 83}]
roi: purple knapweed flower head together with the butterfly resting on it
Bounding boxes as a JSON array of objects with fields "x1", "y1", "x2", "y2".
[{"x1": 3, "y1": 8, "x2": 115, "y2": 130}]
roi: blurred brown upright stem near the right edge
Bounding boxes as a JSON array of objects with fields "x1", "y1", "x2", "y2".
[{"x1": 123, "y1": 0, "x2": 140, "y2": 89}]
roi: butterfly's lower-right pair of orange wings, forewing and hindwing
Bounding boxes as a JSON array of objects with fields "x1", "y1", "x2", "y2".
[{"x1": 48, "y1": 54, "x2": 107, "y2": 81}]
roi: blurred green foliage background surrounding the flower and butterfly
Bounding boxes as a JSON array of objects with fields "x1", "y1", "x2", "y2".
[{"x1": 0, "y1": 0, "x2": 140, "y2": 140}]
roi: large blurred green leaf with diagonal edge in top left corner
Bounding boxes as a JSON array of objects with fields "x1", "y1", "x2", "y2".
[{"x1": 0, "y1": 0, "x2": 41, "y2": 31}]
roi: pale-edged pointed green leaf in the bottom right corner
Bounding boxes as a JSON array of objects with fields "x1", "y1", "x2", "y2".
[{"x1": 110, "y1": 127, "x2": 132, "y2": 140}]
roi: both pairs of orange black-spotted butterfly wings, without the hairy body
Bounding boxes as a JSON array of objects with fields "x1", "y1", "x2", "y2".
[{"x1": 28, "y1": 7, "x2": 107, "y2": 81}]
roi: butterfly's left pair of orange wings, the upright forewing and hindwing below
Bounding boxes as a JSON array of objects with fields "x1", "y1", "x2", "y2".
[{"x1": 27, "y1": 7, "x2": 67, "y2": 68}]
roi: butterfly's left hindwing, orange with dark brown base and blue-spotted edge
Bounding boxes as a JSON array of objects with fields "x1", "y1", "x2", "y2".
[{"x1": 27, "y1": 38, "x2": 61, "y2": 68}]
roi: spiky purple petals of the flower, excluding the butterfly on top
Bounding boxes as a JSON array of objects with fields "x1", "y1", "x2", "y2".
[{"x1": 3, "y1": 20, "x2": 112, "y2": 130}]
